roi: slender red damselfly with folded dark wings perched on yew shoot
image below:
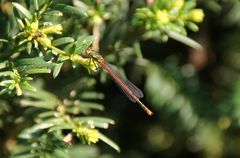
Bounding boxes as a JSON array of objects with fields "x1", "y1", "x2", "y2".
[{"x1": 86, "y1": 50, "x2": 153, "y2": 115}]
